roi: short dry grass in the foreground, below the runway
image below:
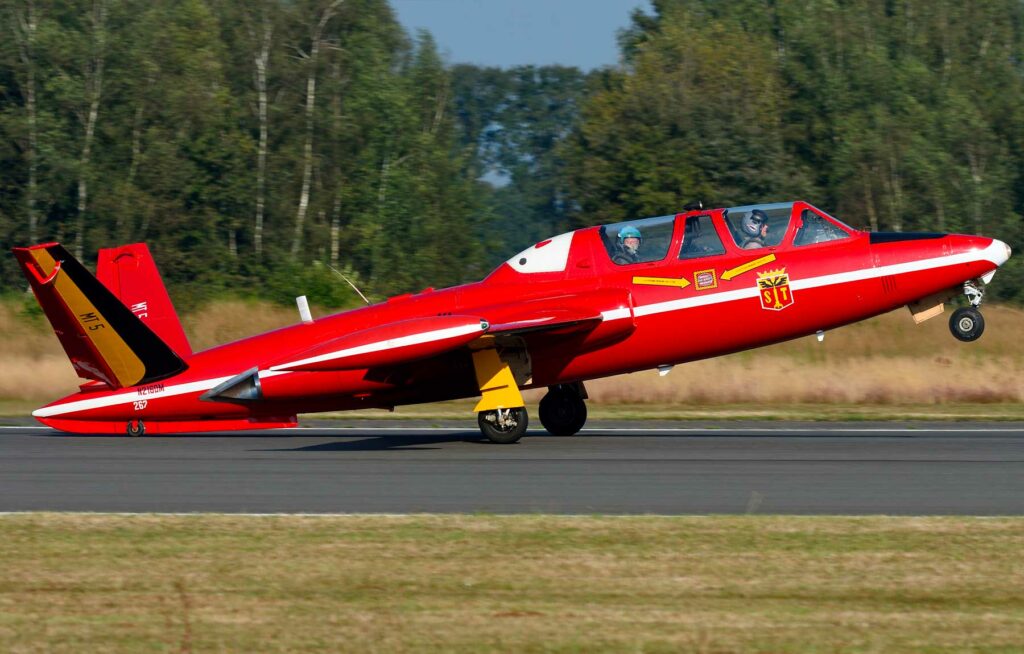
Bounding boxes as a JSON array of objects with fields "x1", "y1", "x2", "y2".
[{"x1": 0, "y1": 514, "x2": 1024, "y2": 653}]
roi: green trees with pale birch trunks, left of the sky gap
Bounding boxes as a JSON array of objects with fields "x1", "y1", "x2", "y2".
[{"x1": 0, "y1": 0, "x2": 484, "y2": 303}]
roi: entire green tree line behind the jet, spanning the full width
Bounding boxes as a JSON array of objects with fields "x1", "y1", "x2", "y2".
[{"x1": 0, "y1": 0, "x2": 1024, "y2": 305}]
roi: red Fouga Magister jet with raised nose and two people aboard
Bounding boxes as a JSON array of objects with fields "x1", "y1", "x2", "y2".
[{"x1": 14, "y1": 202, "x2": 1010, "y2": 443}]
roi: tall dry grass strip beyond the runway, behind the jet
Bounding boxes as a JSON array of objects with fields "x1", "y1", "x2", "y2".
[{"x1": 0, "y1": 301, "x2": 1024, "y2": 416}]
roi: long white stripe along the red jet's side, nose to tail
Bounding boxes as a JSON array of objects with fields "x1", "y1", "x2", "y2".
[{"x1": 32, "y1": 241, "x2": 1007, "y2": 418}]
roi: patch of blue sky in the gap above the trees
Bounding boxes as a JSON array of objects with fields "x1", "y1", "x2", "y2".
[{"x1": 391, "y1": 0, "x2": 650, "y2": 71}]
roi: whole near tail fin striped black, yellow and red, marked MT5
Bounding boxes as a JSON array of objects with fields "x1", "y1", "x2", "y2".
[{"x1": 13, "y1": 243, "x2": 188, "y2": 389}]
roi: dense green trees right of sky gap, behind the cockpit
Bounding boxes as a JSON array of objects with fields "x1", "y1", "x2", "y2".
[{"x1": 563, "y1": 0, "x2": 1024, "y2": 298}]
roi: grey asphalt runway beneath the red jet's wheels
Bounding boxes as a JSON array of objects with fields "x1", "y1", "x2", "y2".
[{"x1": 0, "y1": 421, "x2": 1024, "y2": 515}]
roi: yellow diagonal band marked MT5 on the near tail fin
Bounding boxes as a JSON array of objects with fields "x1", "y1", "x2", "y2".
[{"x1": 31, "y1": 249, "x2": 145, "y2": 386}]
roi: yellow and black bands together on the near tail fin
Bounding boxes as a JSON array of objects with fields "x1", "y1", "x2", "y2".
[{"x1": 23, "y1": 244, "x2": 187, "y2": 387}]
